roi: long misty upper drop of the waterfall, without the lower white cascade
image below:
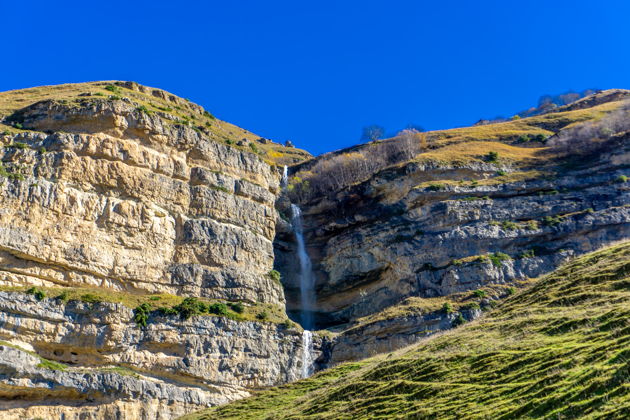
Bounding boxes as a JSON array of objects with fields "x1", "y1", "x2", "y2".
[{"x1": 291, "y1": 204, "x2": 315, "y2": 330}]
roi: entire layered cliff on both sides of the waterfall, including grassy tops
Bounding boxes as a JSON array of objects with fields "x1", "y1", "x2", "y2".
[{"x1": 0, "y1": 82, "x2": 630, "y2": 420}]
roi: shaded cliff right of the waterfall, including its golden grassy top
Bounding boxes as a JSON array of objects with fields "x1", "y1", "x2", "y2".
[{"x1": 275, "y1": 90, "x2": 630, "y2": 364}]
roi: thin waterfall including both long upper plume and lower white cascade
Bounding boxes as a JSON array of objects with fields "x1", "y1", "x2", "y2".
[{"x1": 291, "y1": 204, "x2": 315, "y2": 378}]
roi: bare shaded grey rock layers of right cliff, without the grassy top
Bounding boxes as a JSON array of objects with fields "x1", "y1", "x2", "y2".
[{"x1": 276, "y1": 125, "x2": 630, "y2": 363}]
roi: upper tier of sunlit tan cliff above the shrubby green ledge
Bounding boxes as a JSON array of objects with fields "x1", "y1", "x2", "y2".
[{"x1": 0, "y1": 100, "x2": 284, "y2": 304}]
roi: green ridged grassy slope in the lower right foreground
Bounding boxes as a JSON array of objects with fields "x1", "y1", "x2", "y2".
[{"x1": 186, "y1": 242, "x2": 630, "y2": 420}]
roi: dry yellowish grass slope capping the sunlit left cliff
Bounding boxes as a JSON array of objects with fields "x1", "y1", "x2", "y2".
[{"x1": 0, "y1": 81, "x2": 310, "y2": 165}]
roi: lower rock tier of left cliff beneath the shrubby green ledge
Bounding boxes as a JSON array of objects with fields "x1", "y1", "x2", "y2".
[{"x1": 0, "y1": 292, "x2": 319, "y2": 419}]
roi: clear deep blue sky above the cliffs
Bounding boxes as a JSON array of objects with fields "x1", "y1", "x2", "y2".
[{"x1": 0, "y1": 0, "x2": 630, "y2": 154}]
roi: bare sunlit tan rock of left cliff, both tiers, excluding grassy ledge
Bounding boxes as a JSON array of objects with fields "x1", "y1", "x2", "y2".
[{"x1": 0, "y1": 84, "x2": 317, "y2": 419}]
